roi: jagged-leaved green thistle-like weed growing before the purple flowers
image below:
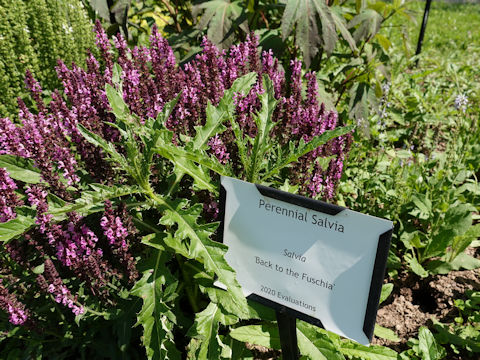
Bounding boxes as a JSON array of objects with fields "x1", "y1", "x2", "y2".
[{"x1": 79, "y1": 73, "x2": 352, "y2": 359}]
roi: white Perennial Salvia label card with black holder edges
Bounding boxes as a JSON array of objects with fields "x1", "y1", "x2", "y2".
[{"x1": 221, "y1": 177, "x2": 392, "y2": 344}]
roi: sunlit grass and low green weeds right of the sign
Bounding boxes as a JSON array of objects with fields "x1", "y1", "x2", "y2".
[{"x1": 339, "y1": 1, "x2": 480, "y2": 359}]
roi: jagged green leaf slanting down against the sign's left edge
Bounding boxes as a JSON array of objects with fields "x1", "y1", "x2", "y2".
[{"x1": 157, "y1": 195, "x2": 248, "y2": 314}]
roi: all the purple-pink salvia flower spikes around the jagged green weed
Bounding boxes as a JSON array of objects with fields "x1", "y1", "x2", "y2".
[{"x1": 0, "y1": 23, "x2": 352, "y2": 325}]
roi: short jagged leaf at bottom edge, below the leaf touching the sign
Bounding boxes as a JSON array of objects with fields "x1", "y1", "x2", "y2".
[{"x1": 188, "y1": 302, "x2": 238, "y2": 360}]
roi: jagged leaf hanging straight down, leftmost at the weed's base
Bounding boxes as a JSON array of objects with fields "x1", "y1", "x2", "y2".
[{"x1": 131, "y1": 251, "x2": 181, "y2": 360}]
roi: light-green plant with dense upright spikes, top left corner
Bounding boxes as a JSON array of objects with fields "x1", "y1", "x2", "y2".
[{"x1": 0, "y1": 0, "x2": 95, "y2": 117}]
